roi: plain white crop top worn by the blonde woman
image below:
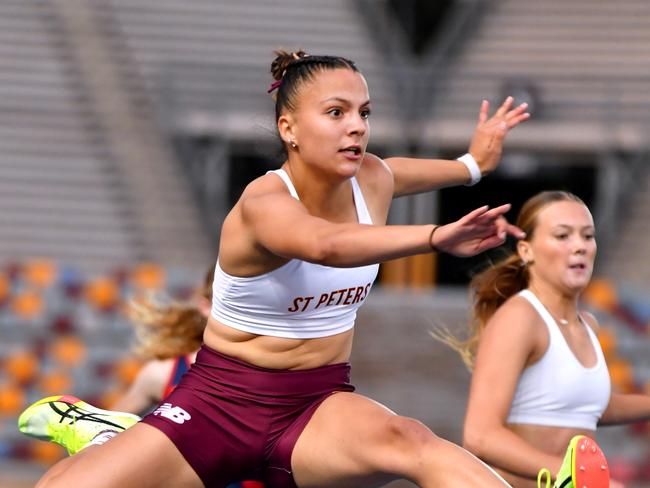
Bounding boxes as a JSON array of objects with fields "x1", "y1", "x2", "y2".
[{"x1": 508, "y1": 290, "x2": 611, "y2": 430}]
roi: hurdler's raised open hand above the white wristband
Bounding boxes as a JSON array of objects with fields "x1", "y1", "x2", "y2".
[{"x1": 469, "y1": 97, "x2": 530, "y2": 175}]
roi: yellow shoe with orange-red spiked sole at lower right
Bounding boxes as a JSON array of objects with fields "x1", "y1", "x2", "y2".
[{"x1": 537, "y1": 435, "x2": 609, "y2": 488}]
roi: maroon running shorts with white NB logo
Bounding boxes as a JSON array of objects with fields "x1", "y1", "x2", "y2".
[{"x1": 142, "y1": 346, "x2": 354, "y2": 488}]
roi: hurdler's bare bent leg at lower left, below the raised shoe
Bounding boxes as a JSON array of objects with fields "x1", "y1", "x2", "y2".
[{"x1": 37, "y1": 423, "x2": 203, "y2": 488}]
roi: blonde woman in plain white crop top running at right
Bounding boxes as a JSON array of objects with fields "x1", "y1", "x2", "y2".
[{"x1": 442, "y1": 191, "x2": 650, "y2": 488}]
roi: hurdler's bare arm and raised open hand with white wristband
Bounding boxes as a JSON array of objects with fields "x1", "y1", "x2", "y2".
[{"x1": 385, "y1": 97, "x2": 530, "y2": 197}]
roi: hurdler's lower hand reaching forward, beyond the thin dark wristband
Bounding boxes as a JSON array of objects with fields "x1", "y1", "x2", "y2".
[{"x1": 432, "y1": 203, "x2": 526, "y2": 257}]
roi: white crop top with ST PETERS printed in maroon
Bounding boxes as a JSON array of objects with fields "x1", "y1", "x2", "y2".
[{"x1": 212, "y1": 169, "x2": 379, "y2": 339}]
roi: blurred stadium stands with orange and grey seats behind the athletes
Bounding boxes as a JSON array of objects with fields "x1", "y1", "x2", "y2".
[{"x1": 0, "y1": 0, "x2": 650, "y2": 488}]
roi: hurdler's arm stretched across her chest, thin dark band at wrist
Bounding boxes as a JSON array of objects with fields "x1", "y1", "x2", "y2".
[{"x1": 242, "y1": 189, "x2": 524, "y2": 268}]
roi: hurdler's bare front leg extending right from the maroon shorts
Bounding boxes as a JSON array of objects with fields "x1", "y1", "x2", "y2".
[{"x1": 291, "y1": 393, "x2": 509, "y2": 488}]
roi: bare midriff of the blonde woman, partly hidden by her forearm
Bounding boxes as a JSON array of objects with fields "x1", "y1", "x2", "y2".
[{"x1": 497, "y1": 424, "x2": 595, "y2": 488}]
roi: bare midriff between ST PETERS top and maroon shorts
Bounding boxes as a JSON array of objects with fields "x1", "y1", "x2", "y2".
[{"x1": 203, "y1": 317, "x2": 354, "y2": 369}]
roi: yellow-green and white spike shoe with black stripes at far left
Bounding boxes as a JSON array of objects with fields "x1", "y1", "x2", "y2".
[{"x1": 18, "y1": 395, "x2": 140, "y2": 454}]
